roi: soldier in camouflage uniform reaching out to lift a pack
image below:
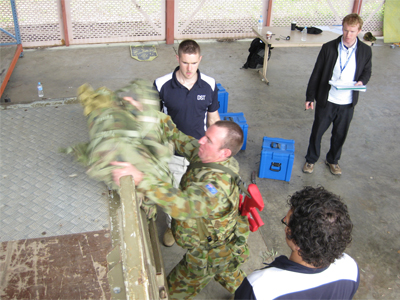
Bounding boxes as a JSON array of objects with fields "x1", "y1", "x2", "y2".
[{"x1": 113, "y1": 121, "x2": 249, "y2": 299}]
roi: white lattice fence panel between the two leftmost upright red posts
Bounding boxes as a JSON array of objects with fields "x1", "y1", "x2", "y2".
[{"x1": 65, "y1": 0, "x2": 165, "y2": 44}]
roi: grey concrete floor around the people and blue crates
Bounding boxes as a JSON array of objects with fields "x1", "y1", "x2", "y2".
[{"x1": 1, "y1": 40, "x2": 400, "y2": 299}]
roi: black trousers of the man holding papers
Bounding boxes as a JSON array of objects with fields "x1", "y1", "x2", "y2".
[{"x1": 306, "y1": 101, "x2": 354, "y2": 164}]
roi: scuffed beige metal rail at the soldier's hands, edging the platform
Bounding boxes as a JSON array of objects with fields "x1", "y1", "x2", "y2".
[{"x1": 107, "y1": 176, "x2": 168, "y2": 300}]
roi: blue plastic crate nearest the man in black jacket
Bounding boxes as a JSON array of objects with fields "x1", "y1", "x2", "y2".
[{"x1": 258, "y1": 137, "x2": 294, "y2": 182}]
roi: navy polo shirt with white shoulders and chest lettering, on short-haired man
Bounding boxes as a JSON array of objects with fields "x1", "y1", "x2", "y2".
[{"x1": 154, "y1": 66, "x2": 219, "y2": 139}]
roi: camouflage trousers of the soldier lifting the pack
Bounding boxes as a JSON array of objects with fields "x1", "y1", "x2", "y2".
[{"x1": 167, "y1": 240, "x2": 249, "y2": 299}]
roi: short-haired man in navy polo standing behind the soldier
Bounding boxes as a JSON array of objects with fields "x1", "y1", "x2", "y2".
[{"x1": 154, "y1": 40, "x2": 220, "y2": 246}]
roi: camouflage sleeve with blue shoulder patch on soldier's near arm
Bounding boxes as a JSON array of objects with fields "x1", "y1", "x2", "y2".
[{"x1": 137, "y1": 172, "x2": 232, "y2": 220}]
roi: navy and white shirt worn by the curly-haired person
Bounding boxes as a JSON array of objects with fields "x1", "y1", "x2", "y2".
[{"x1": 235, "y1": 253, "x2": 360, "y2": 300}]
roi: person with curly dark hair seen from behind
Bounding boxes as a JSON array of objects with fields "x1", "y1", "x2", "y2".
[{"x1": 235, "y1": 186, "x2": 360, "y2": 300}]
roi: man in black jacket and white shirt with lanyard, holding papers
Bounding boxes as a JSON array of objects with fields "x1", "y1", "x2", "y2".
[{"x1": 303, "y1": 14, "x2": 372, "y2": 175}]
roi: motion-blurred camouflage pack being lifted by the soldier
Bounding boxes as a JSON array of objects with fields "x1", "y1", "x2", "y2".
[{"x1": 61, "y1": 79, "x2": 174, "y2": 218}]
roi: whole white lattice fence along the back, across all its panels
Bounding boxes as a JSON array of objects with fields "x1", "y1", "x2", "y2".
[{"x1": 0, "y1": 0, "x2": 385, "y2": 47}]
